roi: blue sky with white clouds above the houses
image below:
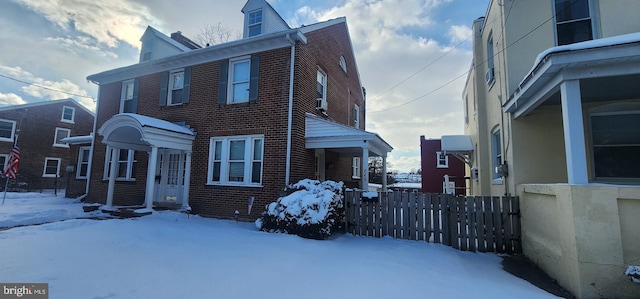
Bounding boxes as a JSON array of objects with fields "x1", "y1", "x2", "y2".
[{"x1": 0, "y1": 0, "x2": 489, "y2": 171}]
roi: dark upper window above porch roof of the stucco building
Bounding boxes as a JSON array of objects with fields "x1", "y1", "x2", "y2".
[{"x1": 555, "y1": 0, "x2": 593, "y2": 46}]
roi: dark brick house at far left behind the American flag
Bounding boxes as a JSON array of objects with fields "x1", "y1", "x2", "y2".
[{"x1": 0, "y1": 99, "x2": 94, "y2": 197}]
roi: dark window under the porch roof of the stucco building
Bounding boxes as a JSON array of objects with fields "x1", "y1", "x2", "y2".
[{"x1": 591, "y1": 114, "x2": 640, "y2": 146}]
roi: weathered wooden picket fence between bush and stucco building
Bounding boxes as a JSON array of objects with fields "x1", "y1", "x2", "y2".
[{"x1": 345, "y1": 190, "x2": 522, "y2": 253}]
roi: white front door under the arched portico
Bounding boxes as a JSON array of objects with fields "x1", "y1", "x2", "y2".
[{"x1": 156, "y1": 149, "x2": 185, "y2": 204}]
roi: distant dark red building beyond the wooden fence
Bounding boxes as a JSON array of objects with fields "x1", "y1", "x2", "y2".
[{"x1": 420, "y1": 136, "x2": 467, "y2": 195}]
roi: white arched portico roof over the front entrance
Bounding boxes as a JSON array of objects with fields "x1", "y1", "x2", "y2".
[{"x1": 98, "y1": 113, "x2": 195, "y2": 151}]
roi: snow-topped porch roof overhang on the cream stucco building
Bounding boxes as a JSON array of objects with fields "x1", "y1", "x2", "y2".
[{"x1": 503, "y1": 33, "x2": 640, "y2": 119}]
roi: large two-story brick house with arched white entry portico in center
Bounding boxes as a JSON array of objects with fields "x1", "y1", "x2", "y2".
[{"x1": 81, "y1": 0, "x2": 392, "y2": 219}]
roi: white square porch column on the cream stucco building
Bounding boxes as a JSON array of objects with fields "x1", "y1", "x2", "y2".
[{"x1": 560, "y1": 80, "x2": 589, "y2": 185}]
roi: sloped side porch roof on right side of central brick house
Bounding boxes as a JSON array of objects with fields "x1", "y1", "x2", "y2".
[{"x1": 305, "y1": 113, "x2": 393, "y2": 157}]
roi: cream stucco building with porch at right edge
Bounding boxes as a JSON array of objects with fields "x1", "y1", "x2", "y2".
[{"x1": 462, "y1": 0, "x2": 640, "y2": 298}]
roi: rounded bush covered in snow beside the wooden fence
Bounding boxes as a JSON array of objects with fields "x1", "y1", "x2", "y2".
[{"x1": 256, "y1": 179, "x2": 344, "y2": 240}]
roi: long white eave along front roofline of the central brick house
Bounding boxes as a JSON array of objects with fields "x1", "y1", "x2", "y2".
[{"x1": 87, "y1": 29, "x2": 307, "y2": 85}]
